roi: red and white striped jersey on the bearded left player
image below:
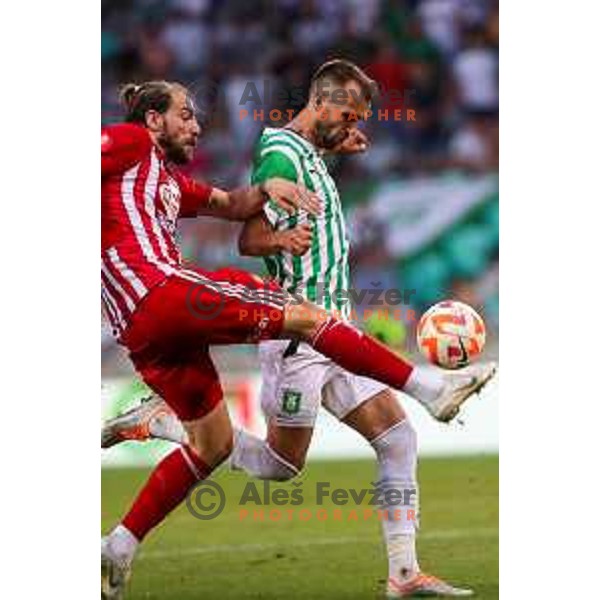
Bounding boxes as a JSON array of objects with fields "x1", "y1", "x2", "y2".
[{"x1": 102, "y1": 123, "x2": 212, "y2": 336}]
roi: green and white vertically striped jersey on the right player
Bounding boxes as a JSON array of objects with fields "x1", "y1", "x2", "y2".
[{"x1": 252, "y1": 127, "x2": 351, "y2": 318}]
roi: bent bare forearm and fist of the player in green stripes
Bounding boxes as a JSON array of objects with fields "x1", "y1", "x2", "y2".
[{"x1": 238, "y1": 214, "x2": 312, "y2": 256}]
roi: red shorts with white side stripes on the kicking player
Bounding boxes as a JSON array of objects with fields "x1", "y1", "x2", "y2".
[{"x1": 120, "y1": 269, "x2": 284, "y2": 421}]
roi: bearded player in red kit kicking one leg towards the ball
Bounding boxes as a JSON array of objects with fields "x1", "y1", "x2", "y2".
[{"x1": 102, "y1": 82, "x2": 494, "y2": 600}]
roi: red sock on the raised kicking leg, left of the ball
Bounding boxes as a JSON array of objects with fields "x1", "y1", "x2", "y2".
[{"x1": 309, "y1": 318, "x2": 413, "y2": 390}]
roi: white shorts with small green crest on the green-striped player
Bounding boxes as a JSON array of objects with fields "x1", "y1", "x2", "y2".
[{"x1": 259, "y1": 340, "x2": 388, "y2": 427}]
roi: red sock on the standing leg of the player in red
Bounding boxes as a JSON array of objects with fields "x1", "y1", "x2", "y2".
[{"x1": 123, "y1": 446, "x2": 212, "y2": 541}]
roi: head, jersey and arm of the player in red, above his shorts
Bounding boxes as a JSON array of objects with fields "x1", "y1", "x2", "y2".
[{"x1": 101, "y1": 83, "x2": 318, "y2": 335}]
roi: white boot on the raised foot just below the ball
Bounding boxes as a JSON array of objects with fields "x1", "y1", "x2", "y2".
[{"x1": 424, "y1": 363, "x2": 498, "y2": 423}]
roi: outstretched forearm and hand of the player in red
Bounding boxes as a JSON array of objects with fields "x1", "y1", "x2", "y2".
[{"x1": 198, "y1": 178, "x2": 321, "y2": 221}]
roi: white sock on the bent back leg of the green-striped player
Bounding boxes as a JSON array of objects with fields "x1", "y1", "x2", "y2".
[{"x1": 230, "y1": 429, "x2": 299, "y2": 481}]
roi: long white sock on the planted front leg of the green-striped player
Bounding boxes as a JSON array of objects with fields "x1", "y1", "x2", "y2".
[{"x1": 371, "y1": 420, "x2": 419, "y2": 580}]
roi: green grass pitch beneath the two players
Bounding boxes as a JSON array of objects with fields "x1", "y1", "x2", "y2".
[{"x1": 102, "y1": 456, "x2": 498, "y2": 600}]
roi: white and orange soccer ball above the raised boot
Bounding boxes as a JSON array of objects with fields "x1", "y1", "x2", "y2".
[{"x1": 417, "y1": 300, "x2": 485, "y2": 369}]
